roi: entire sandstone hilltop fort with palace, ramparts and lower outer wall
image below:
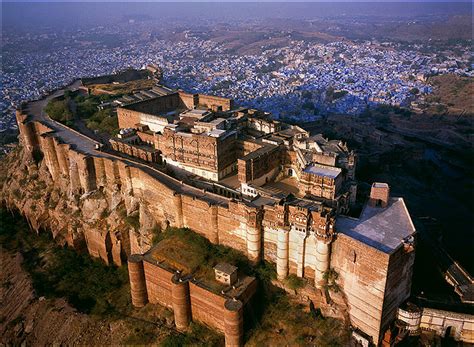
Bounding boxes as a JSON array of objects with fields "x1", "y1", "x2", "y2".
[{"x1": 2, "y1": 79, "x2": 422, "y2": 345}]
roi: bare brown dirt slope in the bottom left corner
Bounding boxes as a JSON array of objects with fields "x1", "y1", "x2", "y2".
[{"x1": 0, "y1": 248, "x2": 172, "y2": 346}]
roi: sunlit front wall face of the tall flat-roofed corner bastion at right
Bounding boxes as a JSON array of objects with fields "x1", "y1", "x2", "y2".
[{"x1": 331, "y1": 233, "x2": 389, "y2": 344}]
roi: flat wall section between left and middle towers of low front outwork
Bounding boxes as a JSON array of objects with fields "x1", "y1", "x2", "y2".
[{"x1": 143, "y1": 261, "x2": 173, "y2": 309}]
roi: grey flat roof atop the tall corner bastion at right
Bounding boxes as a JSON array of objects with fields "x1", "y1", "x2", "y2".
[{"x1": 336, "y1": 198, "x2": 416, "y2": 254}]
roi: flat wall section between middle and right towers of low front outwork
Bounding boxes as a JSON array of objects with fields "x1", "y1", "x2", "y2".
[{"x1": 189, "y1": 282, "x2": 226, "y2": 332}]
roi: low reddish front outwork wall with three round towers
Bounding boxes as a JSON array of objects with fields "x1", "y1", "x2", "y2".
[{"x1": 128, "y1": 254, "x2": 252, "y2": 347}]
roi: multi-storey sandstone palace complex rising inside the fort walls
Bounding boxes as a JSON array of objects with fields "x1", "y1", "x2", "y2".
[{"x1": 118, "y1": 91, "x2": 356, "y2": 211}]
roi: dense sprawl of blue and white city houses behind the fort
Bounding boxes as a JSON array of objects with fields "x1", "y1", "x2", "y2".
[{"x1": 0, "y1": 23, "x2": 472, "y2": 130}]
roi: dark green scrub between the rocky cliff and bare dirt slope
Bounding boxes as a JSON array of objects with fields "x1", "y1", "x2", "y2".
[{"x1": 0, "y1": 209, "x2": 131, "y2": 317}]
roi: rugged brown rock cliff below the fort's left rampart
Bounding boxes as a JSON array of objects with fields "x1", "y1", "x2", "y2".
[{"x1": 0, "y1": 143, "x2": 160, "y2": 265}]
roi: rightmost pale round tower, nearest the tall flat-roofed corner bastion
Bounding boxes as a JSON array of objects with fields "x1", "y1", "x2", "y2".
[{"x1": 314, "y1": 219, "x2": 334, "y2": 288}]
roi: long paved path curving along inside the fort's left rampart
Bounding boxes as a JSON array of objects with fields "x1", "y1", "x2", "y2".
[{"x1": 25, "y1": 81, "x2": 228, "y2": 206}]
